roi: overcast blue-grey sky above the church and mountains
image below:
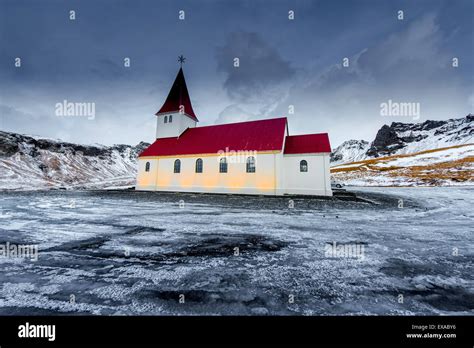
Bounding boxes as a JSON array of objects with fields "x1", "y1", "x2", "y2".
[{"x1": 0, "y1": 0, "x2": 474, "y2": 148}]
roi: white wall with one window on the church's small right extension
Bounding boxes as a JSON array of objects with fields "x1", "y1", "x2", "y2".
[{"x1": 283, "y1": 154, "x2": 332, "y2": 196}]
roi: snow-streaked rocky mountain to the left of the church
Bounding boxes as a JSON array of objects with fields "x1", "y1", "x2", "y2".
[{"x1": 0, "y1": 131, "x2": 149, "y2": 189}]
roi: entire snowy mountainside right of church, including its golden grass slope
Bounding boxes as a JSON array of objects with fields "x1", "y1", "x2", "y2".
[{"x1": 331, "y1": 115, "x2": 474, "y2": 186}]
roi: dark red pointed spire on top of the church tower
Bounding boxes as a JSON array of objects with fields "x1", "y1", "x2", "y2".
[{"x1": 155, "y1": 68, "x2": 199, "y2": 121}]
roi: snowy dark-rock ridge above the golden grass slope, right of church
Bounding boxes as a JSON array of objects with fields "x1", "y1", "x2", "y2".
[{"x1": 331, "y1": 114, "x2": 474, "y2": 166}]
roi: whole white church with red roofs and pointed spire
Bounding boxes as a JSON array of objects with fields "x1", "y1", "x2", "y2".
[{"x1": 136, "y1": 63, "x2": 332, "y2": 196}]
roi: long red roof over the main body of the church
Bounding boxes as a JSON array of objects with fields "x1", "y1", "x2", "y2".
[{"x1": 139, "y1": 117, "x2": 286, "y2": 157}]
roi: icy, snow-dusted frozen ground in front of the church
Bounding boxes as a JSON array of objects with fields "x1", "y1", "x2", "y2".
[{"x1": 0, "y1": 187, "x2": 474, "y2": 315}]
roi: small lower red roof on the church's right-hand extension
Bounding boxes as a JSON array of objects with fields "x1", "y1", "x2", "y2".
[{"x1": 284, "y1": 133, "x2": 331, "y2": 154}]
